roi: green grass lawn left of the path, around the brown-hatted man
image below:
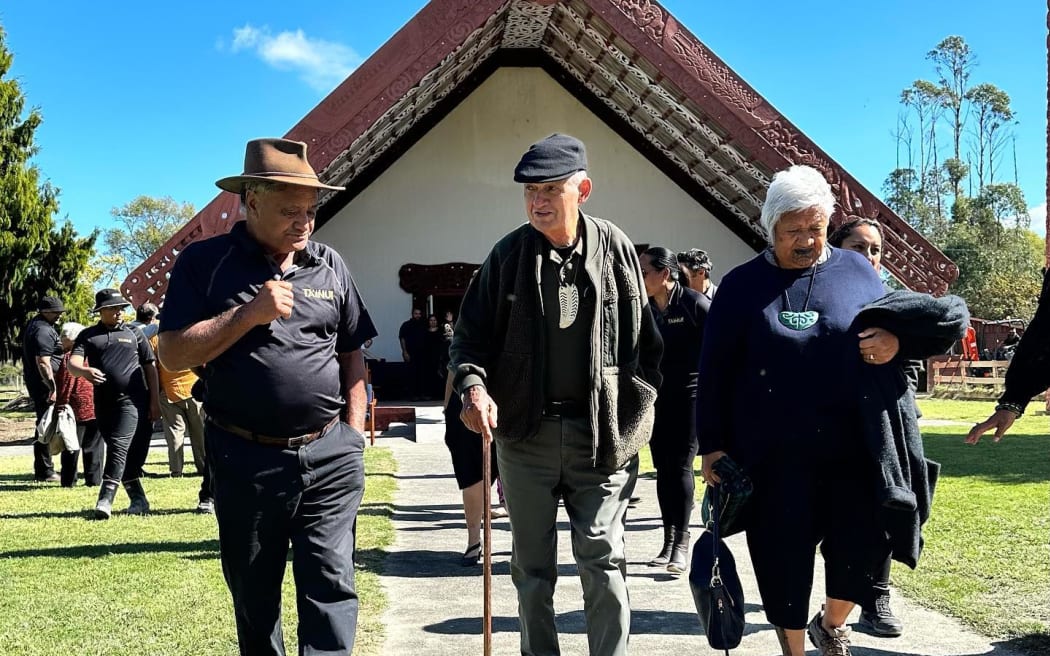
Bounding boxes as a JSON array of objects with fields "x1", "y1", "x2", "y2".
[{"x1": 0, "y1": 447, "x2": 396, "y2": 656}]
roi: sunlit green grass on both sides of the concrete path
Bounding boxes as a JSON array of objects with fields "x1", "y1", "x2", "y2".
[{"x1": 0, "y1": 400, "x2": 1050, "y2": 656}]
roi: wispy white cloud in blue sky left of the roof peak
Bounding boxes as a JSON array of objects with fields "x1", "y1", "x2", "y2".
[{"x1": 223, "y1": 24, "x2": 361, "y2": 92}]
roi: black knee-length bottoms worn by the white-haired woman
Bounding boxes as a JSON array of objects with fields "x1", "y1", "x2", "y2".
[{"x1": 747, "y1": 435, "x2": 889, "y2": 629}]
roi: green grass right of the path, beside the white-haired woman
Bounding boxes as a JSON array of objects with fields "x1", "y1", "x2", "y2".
[{"x1": 893, "y1": 399, "x2": 1050, "y2": 642}]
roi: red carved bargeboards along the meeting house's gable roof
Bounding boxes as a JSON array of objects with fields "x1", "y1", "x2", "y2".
[{"x1": 123, "y1": 0, "x2": 961, "y2": 303}]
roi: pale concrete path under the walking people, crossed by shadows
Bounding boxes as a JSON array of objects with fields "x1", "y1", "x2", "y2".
[{"x1": 376, "y1": 406, "x2": 1021, "y2": 656}]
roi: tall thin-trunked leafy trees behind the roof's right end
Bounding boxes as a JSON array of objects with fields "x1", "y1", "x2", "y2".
[{"x1": 883, "y1": 37, "x2": 1044, "y2": 319}]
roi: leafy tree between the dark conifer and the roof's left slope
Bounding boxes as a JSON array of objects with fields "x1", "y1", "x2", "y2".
[{"x1": 100, "y1": 196, "x2": 196, "y2": 280}]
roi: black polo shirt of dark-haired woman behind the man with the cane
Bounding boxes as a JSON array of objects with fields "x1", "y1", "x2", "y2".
[{"x1": 649, "y1": 283, "x2": 711, "y2": 399}]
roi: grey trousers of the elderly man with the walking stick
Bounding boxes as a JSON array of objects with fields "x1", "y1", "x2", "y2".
[{"x1": 497, "y1": 418, "x2": 638, "y2": 656}]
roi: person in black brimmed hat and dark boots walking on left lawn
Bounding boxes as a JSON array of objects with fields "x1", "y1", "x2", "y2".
[{"x1": 66, "y1": 289, "x2": 161, "y2": 520}]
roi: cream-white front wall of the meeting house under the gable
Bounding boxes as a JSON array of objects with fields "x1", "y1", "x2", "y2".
[{"x1": 314, "y1": 68, "x2": 754, "y2": 361}]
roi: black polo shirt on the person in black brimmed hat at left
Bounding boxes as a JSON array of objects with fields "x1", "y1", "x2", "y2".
[{"x1": 72, "y1": 321, "x2": 153, "y2": 407}]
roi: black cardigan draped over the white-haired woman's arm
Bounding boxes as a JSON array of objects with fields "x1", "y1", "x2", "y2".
[{"x1": 855, "y1": 292, "x2": 969, "y2": 568}]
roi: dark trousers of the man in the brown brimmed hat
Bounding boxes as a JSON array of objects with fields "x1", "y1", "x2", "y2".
[{"x1": 205, "y1": 422, "x2": 364, "y2": 656}]
